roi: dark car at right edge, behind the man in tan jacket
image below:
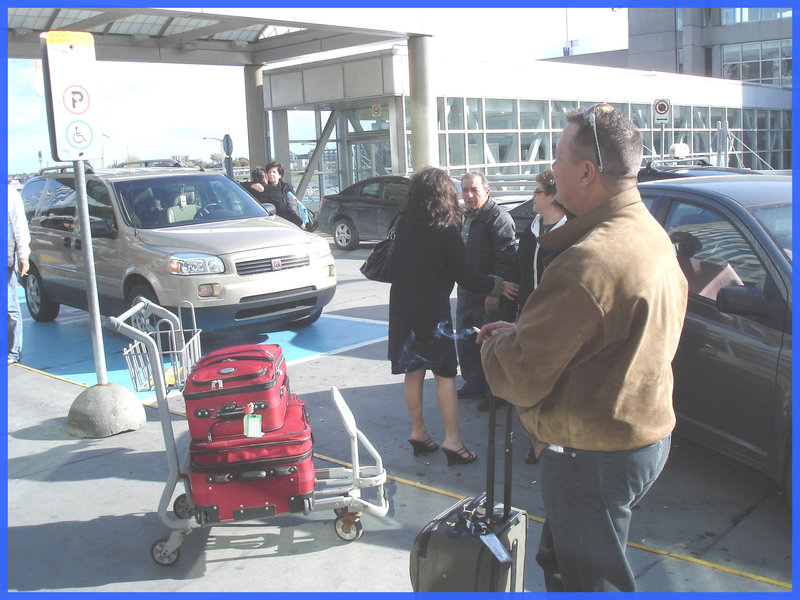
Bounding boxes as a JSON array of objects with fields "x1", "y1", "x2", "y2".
[{"x1": 639, "y1": 175, "x2": 792, "y2": 498}]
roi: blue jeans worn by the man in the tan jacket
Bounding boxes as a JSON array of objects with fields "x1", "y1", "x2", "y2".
[{"x1": 536, "y1": 435, "x2": 671, "y2": 592}]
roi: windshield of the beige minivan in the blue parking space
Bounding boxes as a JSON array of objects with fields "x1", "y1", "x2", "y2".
[{"x1": 112, "y1": 175, "x2": 268, "y2": 229}]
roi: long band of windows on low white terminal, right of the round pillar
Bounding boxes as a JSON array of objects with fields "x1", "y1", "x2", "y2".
[{"x1": 416, "y1": 97, "x2": 792, "y2": 175}]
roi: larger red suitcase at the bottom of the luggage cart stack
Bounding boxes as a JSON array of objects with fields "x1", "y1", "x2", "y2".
[{"x1": 189, "y1": 395, "x2": 315, "y2": 523}]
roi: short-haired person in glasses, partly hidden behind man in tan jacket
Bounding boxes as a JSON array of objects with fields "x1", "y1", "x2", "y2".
[{"x1": 511, "y1": 169, "x2": 567, "y2": 465}]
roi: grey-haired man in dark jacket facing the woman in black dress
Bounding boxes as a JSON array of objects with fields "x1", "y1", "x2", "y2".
[{"x1": 456, "y1": 172, "x2": 515, "y2": 410}]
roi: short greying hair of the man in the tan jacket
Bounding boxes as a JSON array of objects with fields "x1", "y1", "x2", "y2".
[{"x1": 567, "y1": 107, "x2": 644, "y2": 179}]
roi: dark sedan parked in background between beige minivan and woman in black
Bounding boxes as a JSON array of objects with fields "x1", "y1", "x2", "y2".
[{"x1": 318, "y1": 175, "x2": 410, "y2": 250}]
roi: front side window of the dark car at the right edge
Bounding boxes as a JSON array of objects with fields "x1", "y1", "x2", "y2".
[{"x1": 665, "y1": 202, "x2": 767, "y2": 300}]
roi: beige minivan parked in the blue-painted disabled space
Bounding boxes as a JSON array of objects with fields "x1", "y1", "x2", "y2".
[{"x1": 22, "y1": 167, "x2": 336, "y2": 330}]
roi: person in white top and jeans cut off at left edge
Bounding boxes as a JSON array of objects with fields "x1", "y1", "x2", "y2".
[{"x1": 8, "y1": 185, "x2": 31, "y2": 364}]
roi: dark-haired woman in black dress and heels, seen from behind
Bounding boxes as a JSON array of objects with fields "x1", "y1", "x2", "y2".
[{"x1": 389, "y1": 167, "x2": 519, "y2": 465}]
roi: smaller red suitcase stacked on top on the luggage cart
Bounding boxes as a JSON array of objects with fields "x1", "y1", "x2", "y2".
[{"x1": 183, "y1": 344, "x2": 289, "y2": 440}]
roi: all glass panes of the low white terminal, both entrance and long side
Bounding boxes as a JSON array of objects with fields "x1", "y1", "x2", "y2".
[{"x1": 278, "y1": 97, "x2": 792, "y2": 201}]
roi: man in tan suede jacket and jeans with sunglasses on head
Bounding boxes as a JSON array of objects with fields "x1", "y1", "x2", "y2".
[{"x1": 478, "y1": 104, "x2": 687, "y2": 592}]
